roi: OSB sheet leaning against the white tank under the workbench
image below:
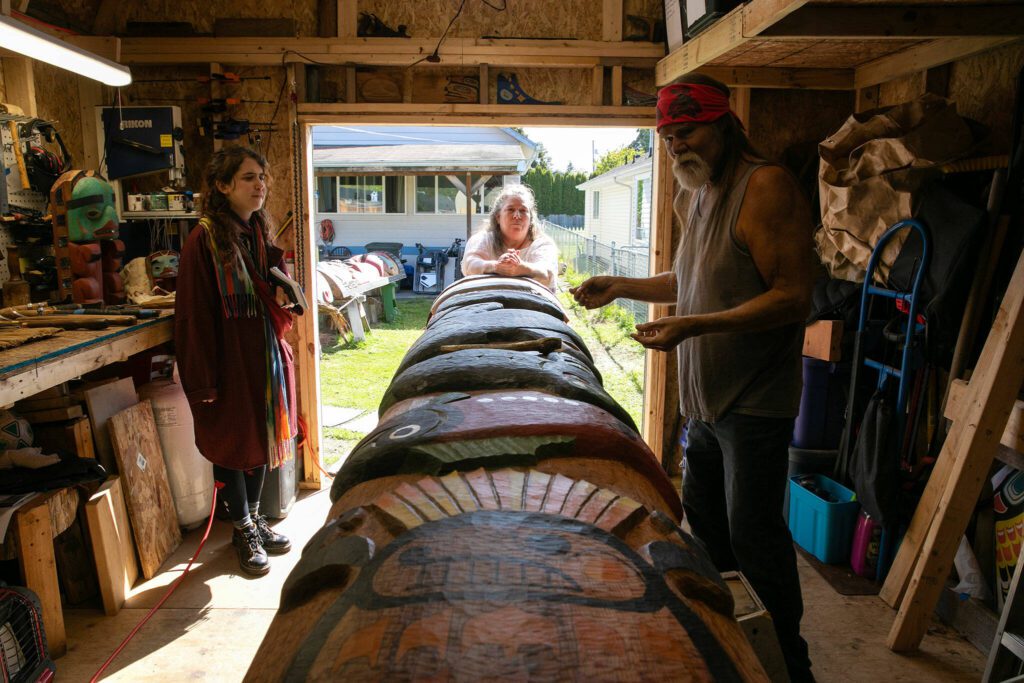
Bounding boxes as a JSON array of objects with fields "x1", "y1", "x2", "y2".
[{"x1": 110, "y1": 399, "x2": 181, "y2": 579}]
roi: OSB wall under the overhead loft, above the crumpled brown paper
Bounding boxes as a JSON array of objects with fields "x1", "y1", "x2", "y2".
[{"x1": 879, "y1": 44, "x2": 1024, "y2": 155}]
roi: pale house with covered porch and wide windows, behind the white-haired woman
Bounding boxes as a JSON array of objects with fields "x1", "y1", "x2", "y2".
[{"x1": 312, "y1": 126, "x2": 537, "y2": 254}]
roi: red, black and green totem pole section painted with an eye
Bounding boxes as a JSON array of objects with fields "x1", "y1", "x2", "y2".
[{"x1": 331, "y1": 391, "x2": 682, "y2": 520}]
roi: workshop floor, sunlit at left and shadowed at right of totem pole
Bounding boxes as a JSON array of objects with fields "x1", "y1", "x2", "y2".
[{"x1": 56, "y1": 490, "x2": 985, "y2": 683}]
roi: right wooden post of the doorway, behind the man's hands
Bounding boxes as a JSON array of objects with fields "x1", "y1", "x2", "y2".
[{"x1": 642, "y1": 139, "x2": 676, "y2": 462}]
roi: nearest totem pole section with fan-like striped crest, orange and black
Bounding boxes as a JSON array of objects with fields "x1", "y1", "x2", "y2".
[{"x1": 246, "y1": 469, "x2": 768, "y2": 681}]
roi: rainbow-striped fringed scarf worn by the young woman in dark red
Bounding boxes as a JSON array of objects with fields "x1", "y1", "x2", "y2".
[{"x1": 200, "y1": 218, "x2": 297, "y2": 469}]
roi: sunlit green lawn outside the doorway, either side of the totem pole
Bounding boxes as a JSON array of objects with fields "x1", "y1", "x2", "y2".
[{"x1": 321, "y1": 282, "x2": 644, "y2": 469}]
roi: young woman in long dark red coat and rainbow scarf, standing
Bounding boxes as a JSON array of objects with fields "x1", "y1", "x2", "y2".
[{"x1": 174, "y1": 147, "x2": 296, "y2": 574}]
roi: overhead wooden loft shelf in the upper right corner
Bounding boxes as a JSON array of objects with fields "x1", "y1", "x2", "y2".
[{"x1": 655, "y1": 0, "x2": 1024, "y2": 89}]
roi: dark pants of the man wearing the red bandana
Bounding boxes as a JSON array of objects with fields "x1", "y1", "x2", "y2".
[{"x1": 683, "y1": 414, "x2": 813, "y2": 681}]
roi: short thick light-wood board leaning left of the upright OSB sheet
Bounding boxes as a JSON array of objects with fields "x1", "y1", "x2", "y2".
[{"x1": 85, "y1": 476, "x2": 138, "y2": 616}]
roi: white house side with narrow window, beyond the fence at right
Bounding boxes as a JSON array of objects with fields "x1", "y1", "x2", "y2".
[{"x1": 577, "y1": 157, "x2": 652, "y2": 249}]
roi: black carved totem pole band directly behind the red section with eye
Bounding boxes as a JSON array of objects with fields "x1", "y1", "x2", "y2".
[{"x1": 380, "y1": 349, "x2": 637, "y2": 430}]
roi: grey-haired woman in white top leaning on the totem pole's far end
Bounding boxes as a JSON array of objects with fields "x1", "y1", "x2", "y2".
[{"x1": 462, "y1": 185, "x2": 558, "y2": 291}]
